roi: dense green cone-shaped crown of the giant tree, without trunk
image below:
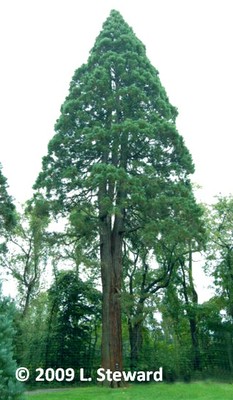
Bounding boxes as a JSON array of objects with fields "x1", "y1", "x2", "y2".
[{"x1": 37, "y1": 10, "x2": 194, "y2": 227}]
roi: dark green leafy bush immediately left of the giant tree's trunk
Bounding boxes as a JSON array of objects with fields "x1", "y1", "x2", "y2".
[{"x1": 45, "y1": 271, "x2": 101, "y2": 373}]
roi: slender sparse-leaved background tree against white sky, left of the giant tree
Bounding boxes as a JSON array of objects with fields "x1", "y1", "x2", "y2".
[{"x1": 1, "y1": 199, "x2": 49, "y2": 316}]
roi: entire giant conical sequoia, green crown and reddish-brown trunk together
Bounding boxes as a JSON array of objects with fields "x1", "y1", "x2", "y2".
[{"x1": 35, "y1": 11, "x2": 200, "y2": 386}]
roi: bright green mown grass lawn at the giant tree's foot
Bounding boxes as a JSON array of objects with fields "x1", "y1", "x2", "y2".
[{"x1": 25, "y1": 382, "x2": 233, "y2": 400}]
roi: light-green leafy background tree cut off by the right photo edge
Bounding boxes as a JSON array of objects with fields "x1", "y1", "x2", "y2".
[{"x1": 203, "y1": 196, "x2": 233, "y2": 371}]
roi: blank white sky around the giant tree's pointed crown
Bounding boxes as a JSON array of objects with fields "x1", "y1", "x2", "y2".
[{"x1": 0, "y1": 0, "x2": 233, "y2": 300}]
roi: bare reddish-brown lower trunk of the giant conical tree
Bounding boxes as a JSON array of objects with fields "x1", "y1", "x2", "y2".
[{"x1": 100, "y1": 217, "x2": 122, "y2": 387}]
